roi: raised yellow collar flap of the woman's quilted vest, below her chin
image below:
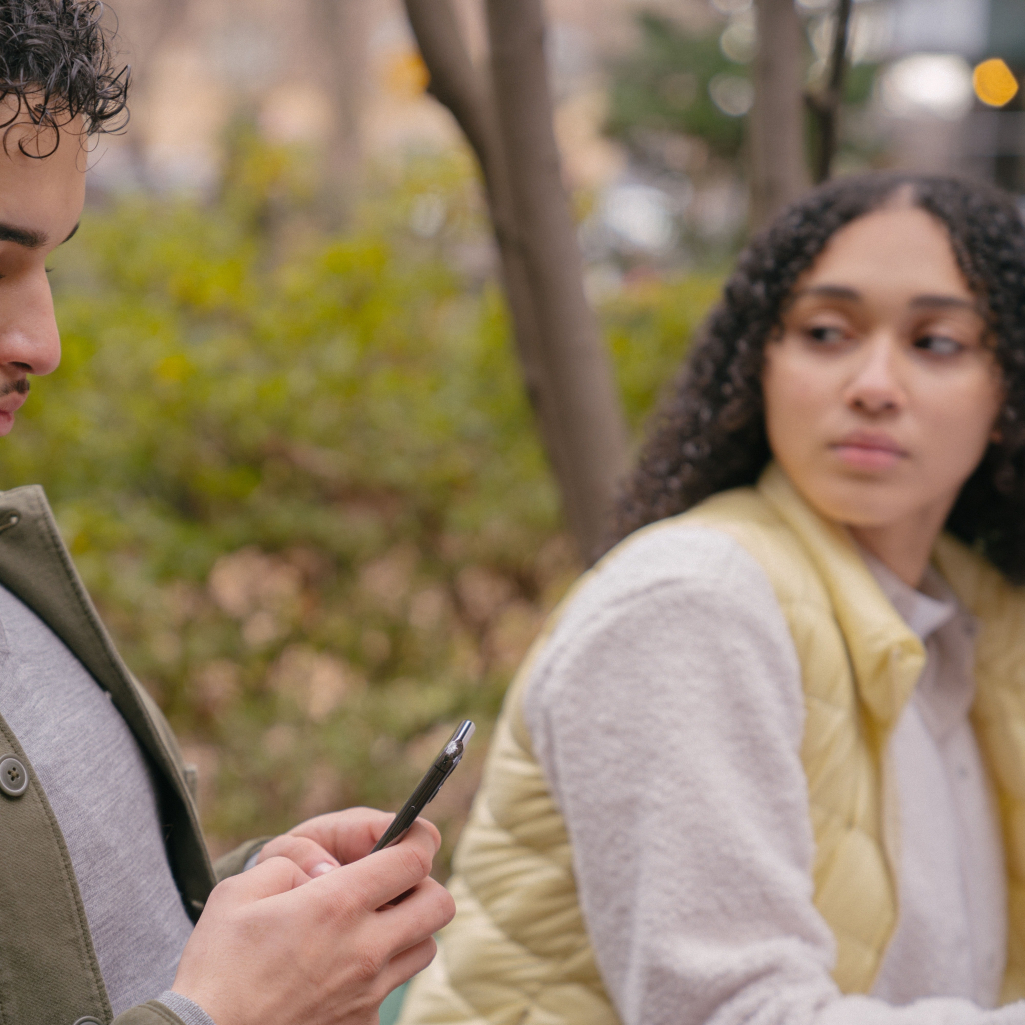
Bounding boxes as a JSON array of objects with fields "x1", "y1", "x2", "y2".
[{"x1": 757, "y1": 462, "x2": 926, "y2": 729}]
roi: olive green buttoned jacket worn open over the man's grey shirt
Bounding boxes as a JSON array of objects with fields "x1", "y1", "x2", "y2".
[{"x1": 0, "y1": 487, "x2": 260, "y2": 1025}]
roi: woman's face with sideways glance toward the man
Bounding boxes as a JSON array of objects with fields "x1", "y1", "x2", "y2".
[{"x1": 763, "y1": 207, "x2": 1001, "y2": 544}]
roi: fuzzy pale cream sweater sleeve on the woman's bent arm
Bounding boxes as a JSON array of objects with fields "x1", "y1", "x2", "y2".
[{"x1": 524, "y1": 527, "x2": 1025, "y2": 1025}]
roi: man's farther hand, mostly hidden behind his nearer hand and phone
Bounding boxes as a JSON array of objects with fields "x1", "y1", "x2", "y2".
[{"x1": 256, "y1": 808, "x2": 412, "y2": 878}]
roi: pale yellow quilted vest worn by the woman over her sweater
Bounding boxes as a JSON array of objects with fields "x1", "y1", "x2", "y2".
[{"x1": 400, "y1": 465, "x2": 1025, "y2": 1025}]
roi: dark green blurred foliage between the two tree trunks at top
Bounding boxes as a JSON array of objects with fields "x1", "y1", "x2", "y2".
[{"x1": 606, "y1": 11, "x2": 748, "y2": 157}]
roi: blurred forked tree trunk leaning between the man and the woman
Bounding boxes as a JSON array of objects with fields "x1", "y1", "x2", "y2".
[{"x1": 405, "y1": 0, "x2": 628, "y2": 562}]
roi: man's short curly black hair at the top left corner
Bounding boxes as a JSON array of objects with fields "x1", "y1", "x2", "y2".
[{"x1": 0, "y1": 0, "x2": 130, "y2": 157}]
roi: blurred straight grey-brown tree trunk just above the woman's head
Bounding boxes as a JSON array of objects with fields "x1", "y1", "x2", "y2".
[{"x1": 751, "y1": 0, "x2": 809, "y2": 230}]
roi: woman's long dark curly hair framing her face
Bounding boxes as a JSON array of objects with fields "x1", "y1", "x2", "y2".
[{"x1": 615, "y1": 172, "x2": 1025, "y2": 583}]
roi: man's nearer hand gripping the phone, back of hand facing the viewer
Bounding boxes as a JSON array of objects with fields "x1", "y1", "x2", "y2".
[{"x1": 172, "y1": 809, "x2": 455, "y2": 1025}]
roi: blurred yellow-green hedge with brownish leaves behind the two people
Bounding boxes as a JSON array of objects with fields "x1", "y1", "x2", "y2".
[{"x1": 0, "y1": 131, "x2": 714, "y2": 876}]
